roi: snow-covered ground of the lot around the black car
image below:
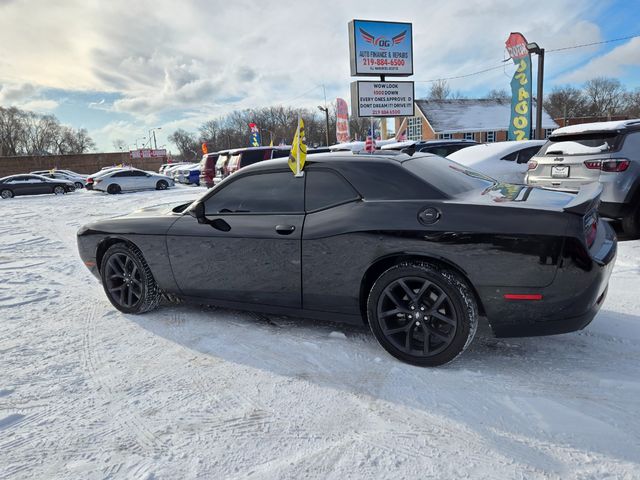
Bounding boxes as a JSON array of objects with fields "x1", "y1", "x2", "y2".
[{"x1": 0, "y1": 187, "x2": 640, "y2": 479}]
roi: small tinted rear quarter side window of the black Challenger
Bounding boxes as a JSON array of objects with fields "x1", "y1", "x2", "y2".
[{"x1": 305, "y1": 170, "x2": 360, "y2": 212}]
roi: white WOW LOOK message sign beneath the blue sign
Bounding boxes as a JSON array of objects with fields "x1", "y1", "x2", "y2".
[{"x1": 351, "y1": 81, "x2": 415, "y2": 117}]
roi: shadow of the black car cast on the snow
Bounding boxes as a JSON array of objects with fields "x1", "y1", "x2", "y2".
[{"x1": 126, "y1": 305, "x2": 640, "y2": 471}]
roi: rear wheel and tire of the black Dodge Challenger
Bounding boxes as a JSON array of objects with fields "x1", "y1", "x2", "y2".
[{"x1": 367, "y1": 262, "x2": 478, "y2": 367}]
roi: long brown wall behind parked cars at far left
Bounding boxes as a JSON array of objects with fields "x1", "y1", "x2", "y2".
[{"x1": 0, "y1": 152, "x2": 167, "y2": 177}]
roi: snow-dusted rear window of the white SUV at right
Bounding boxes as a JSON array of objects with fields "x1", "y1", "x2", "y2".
[{"x1": 538, "y1": 132, "x2": 623, "y2": 156}]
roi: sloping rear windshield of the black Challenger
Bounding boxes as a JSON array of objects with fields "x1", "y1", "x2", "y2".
[{"x1": 402, "y1": 155, "x2": 497, "y2": 196}]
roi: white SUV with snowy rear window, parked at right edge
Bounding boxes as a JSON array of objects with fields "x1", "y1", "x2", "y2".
[{"x1": 525, "y1": 119, "x2": 640, "y2": 236}]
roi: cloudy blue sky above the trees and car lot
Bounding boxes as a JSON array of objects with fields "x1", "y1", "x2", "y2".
[{"x1": 0, "y1": 0, "x2": 640, "y2": 151}]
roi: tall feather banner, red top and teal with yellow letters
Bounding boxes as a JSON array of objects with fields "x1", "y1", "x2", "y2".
[{"x1": 506, "y1": 32, "x2": 531, "y2": 140}]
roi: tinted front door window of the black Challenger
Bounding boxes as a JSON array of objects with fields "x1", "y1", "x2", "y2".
[{"x1": 204, "y1": 172, "x2": 304, "y2": 215}]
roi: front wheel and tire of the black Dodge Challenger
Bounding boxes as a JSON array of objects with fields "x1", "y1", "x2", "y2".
[{"x1": 100, "y1": 243, "x2": 162, "y2": 314}]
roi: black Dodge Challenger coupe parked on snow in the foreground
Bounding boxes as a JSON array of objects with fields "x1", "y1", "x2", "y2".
[{"x1": 78, "y1": 152, "x2": 616, "y2": 366}]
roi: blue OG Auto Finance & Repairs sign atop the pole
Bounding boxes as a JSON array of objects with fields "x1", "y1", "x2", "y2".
[{"x1": 349, "y1": 20, "x2": 413, "y2": 77}]
